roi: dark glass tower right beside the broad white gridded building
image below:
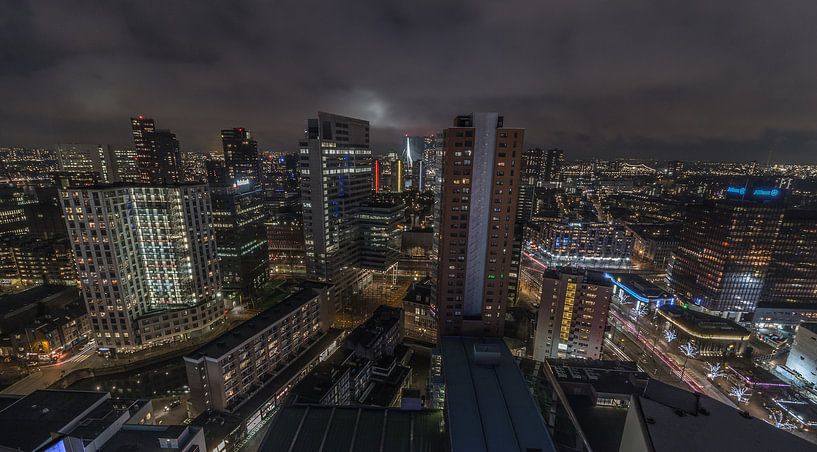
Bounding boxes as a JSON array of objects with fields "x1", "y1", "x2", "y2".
[{"x1": 210, "y1": 179, "x2": 268, "y2": 306}]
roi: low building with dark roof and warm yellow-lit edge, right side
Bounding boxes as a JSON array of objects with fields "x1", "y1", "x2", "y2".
[{"x1": 658, "y1": 304, "x2": 751, "y2": 341}]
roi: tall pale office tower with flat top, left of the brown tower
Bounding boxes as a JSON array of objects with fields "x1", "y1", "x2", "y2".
[{"x1": 300, "y1": 112, "x2": 372, "y2": 310}]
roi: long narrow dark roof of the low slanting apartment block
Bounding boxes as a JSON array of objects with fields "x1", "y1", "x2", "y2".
[{"x1": 185, "y1": 287, "x2": 326, "y2": 360}]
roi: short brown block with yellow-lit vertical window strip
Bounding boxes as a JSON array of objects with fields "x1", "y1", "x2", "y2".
[{"x1": 533, "y1": 268, "x2": 613, "y2": 361}]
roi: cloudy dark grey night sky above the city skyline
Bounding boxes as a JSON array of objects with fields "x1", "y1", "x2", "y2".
[{"x1": 0, "y1": 0, "x2": 817, "y2": 163}]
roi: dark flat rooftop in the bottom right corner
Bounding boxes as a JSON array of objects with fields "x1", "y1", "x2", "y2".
[{"x1": 631, "y1": 380, "x2": 817, "y2": 452}]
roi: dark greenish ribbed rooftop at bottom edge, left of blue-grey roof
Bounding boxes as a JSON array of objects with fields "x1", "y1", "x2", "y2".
[{"x1": 259, "y1": 405, "x2": 446, "y2": 452}]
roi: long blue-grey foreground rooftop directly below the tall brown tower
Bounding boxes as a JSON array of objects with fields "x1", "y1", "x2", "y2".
[{"x1": 439, "y1": 336, "x2": 555, "y2": 452}]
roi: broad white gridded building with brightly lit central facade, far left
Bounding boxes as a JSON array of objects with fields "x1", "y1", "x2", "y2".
[{"x1": 61, "y1": 184, "x2": 224, "y2": 351}]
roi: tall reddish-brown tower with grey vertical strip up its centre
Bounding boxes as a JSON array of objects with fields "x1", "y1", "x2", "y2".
[{"x1": 436, "y1": 113, "x2": 525, "y2": 336}]
